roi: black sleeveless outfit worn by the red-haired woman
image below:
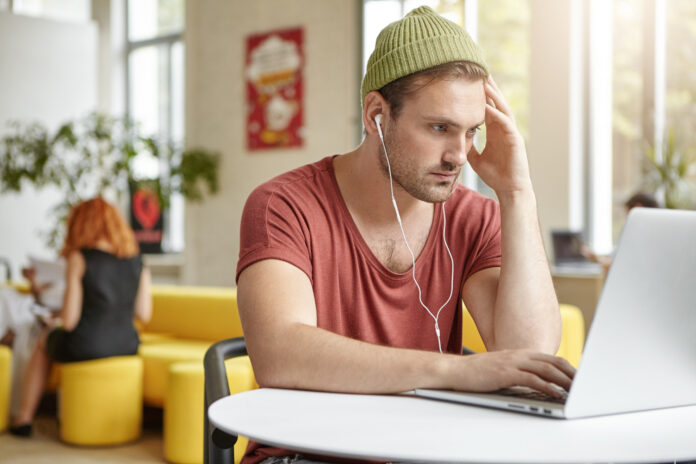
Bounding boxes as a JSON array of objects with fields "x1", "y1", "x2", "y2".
[{"x1": 58, "y1": 249, "x2": 143, "y2": 362}]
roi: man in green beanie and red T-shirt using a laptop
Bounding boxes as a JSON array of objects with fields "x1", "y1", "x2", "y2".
[{"x1": 237, "y1": 7, "x2": 574, "y2": 463}]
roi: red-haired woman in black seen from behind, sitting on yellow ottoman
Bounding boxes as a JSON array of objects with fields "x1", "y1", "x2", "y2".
[{"x1": 10, "y1": 197, "x2": 152, "y2": 436}]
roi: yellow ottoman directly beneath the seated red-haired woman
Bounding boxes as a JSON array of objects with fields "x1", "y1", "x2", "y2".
[{"x1": 58, "y1": 356, "x2": 143, "y2": 445}]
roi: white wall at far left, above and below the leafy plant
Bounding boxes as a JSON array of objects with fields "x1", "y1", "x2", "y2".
[{"x1": 0, "y1": 13, "x2": 97, "y2": 278}]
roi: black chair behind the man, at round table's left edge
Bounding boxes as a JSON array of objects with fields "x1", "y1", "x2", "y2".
[{"x1": 203, "y1": 337, "x2": 247, "y2": 464}]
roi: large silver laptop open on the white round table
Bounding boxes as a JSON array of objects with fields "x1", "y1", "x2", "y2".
[{"x1": 415, "y1": 208, "x2": 696, "y2": 419}]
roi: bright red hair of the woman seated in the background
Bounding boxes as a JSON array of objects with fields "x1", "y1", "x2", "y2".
[{"x1": 60, "y1": 197, "x2": 139, "y2": 258}]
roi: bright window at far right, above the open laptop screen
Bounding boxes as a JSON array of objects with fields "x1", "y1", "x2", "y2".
[{"x1": 607, "y1": 0, "x2": 696, "y2": 245}]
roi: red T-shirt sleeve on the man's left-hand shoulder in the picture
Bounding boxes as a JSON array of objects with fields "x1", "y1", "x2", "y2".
[{"x1": 236, "y1": 183, "x2": 312, "y2": 281}]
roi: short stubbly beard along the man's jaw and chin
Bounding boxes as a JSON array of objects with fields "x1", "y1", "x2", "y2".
[{"x1": 379, "y1": 131, "x2": 460, "y2": 203}]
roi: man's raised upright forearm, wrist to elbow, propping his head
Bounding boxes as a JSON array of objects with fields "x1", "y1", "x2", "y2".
[{"x1": 494, "y1": 186, "x2": 561, "y2": 354}]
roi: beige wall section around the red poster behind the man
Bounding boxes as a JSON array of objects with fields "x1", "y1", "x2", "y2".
[{"x1": 182, "y1": 0, "x2": 361, "y2": 285}]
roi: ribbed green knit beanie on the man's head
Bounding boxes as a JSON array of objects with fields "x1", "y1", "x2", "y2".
[{"x1": 361, "y1": 6, "x2": 488, "y2": 103}]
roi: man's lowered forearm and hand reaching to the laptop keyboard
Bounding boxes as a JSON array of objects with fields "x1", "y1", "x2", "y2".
[{"x1": 247, "y1": 324, "x2": 573, "y2": 395}]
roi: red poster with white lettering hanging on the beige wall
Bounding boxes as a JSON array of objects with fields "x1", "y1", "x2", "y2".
[{"x1": 245, "y1": 28, "x2": 304, "y2": 151}]
